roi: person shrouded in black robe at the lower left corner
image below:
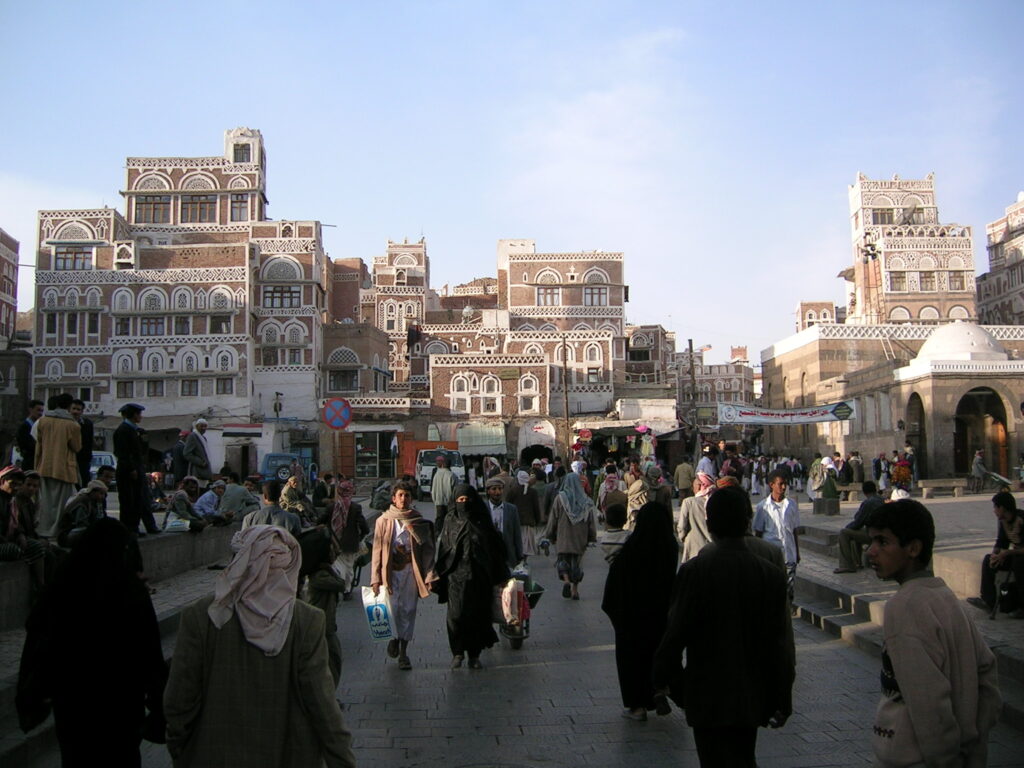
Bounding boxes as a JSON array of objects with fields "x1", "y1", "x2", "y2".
[{"x1": 17, "y1": 518, "x2": 167, "y2": 768}]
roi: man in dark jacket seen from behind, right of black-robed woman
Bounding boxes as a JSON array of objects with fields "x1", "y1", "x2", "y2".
[{"x1": 653, "y1": 487, "x2": 795, "y2": 768}]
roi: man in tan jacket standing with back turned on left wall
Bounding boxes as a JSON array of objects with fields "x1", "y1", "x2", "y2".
[{"x1": 33, "y1": 392, "x2": 82, "y2": 538}]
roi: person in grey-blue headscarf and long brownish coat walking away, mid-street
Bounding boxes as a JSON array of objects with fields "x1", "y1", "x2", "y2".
[{"x1": 542, "y1": 472, "x2": 597, "y2": 600}]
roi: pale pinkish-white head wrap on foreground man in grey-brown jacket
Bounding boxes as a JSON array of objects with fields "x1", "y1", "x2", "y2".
[{"x1": 207, "y1": 525, "x2": 302, "y2": 656}]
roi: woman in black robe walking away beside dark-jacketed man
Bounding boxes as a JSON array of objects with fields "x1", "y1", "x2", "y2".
[{"x1": 601, "y1": 499, "x2": 690, "y2": 720}]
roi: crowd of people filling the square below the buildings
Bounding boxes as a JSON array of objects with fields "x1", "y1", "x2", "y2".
[{"x1": 0, "y1": 415, "x2": 1007, "y2": 766}]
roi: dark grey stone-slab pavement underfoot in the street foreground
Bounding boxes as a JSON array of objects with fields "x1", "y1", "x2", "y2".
[{"x1": 18, "y1": 495, "x2": 1024, "y2": 768}]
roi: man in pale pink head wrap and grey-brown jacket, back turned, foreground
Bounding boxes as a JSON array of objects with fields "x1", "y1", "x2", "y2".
[{"x1": 164, "y1": 525, "x2": 355, "y2": 768}]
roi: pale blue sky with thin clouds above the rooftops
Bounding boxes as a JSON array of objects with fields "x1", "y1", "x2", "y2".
[{"x1": 0, "y1": 0, "x2": 1024, "y2": 362}]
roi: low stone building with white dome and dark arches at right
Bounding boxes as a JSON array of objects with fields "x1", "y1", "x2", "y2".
[{"x1": 762, "y1": 322, "x2": 1024, "y2": 478}]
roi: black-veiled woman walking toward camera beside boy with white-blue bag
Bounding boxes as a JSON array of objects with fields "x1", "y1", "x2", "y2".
[{"x1": 433, "y1": 483, "x2": 509, "y2": 670}]
